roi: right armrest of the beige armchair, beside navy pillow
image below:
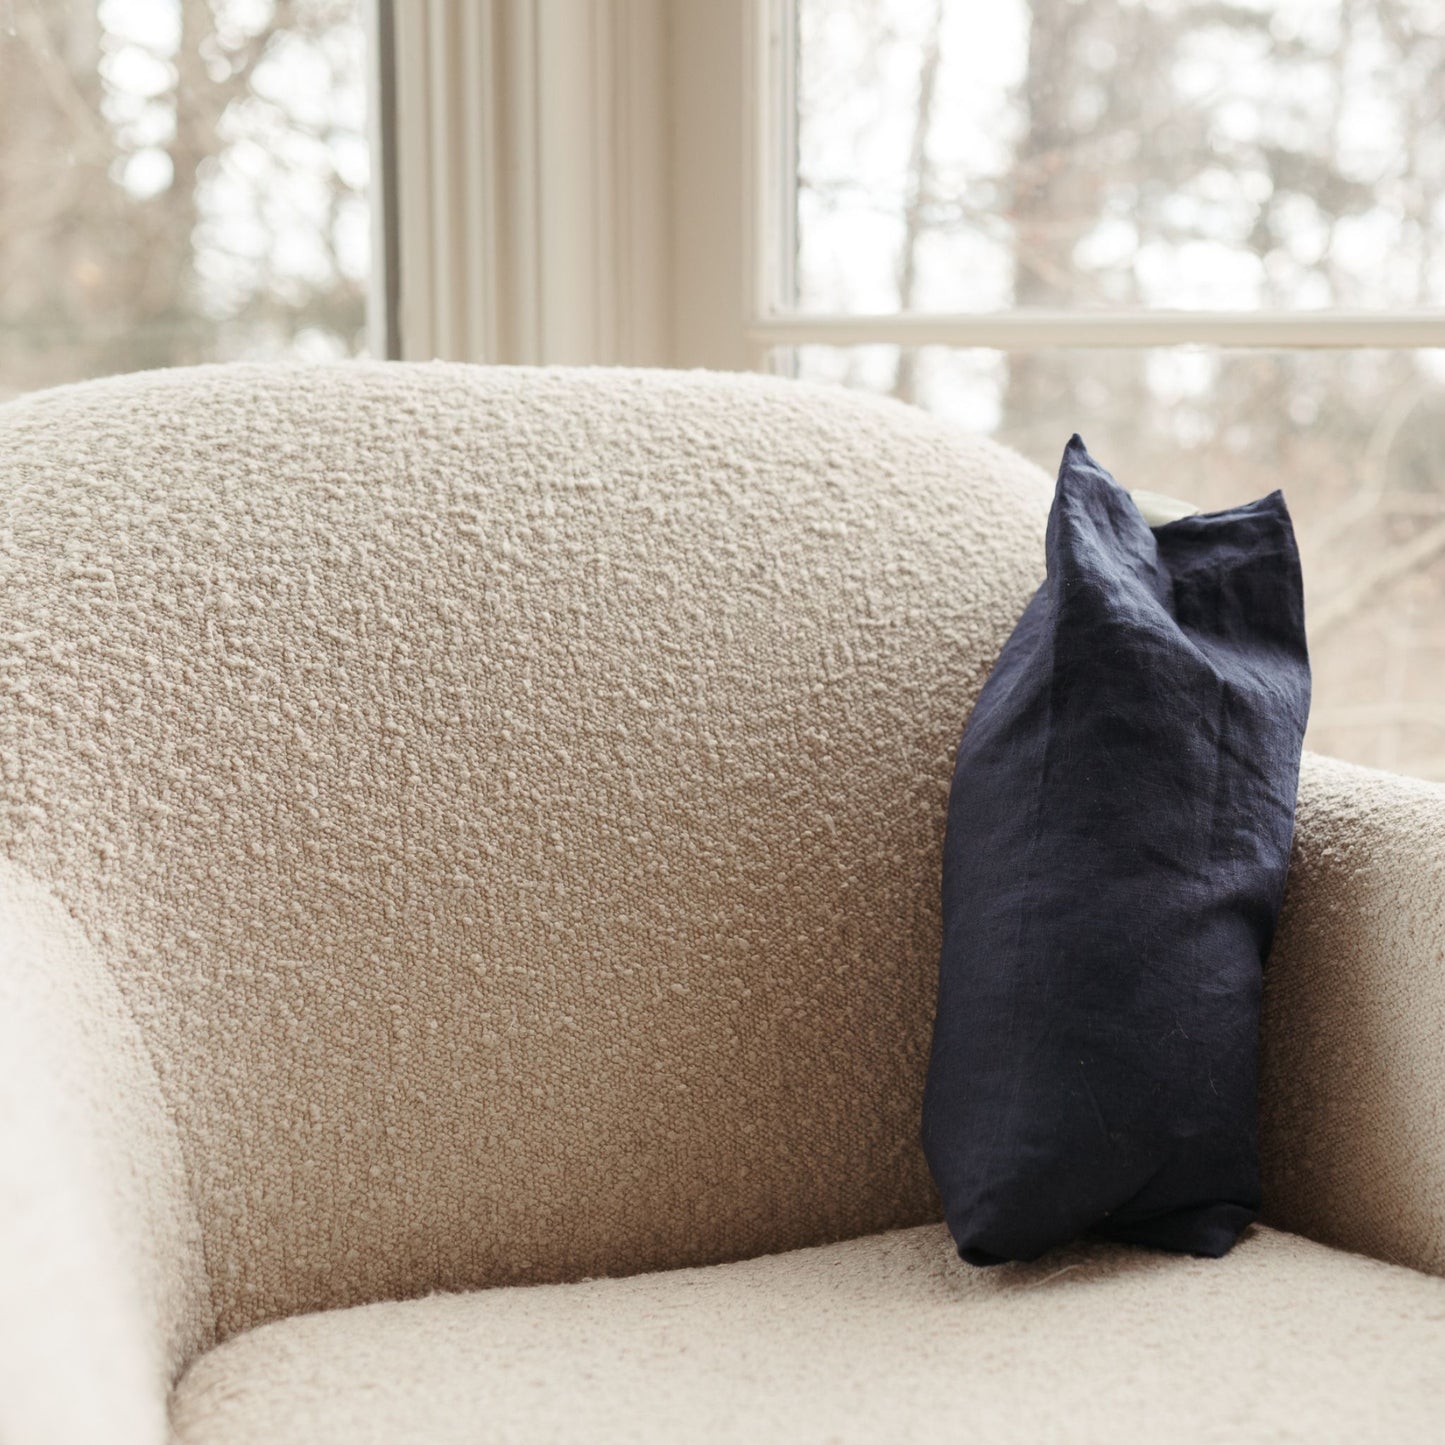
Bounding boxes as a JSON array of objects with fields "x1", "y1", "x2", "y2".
[{"x1": 1260, "y1": 753, "x2": 1445, "y2": 1274}]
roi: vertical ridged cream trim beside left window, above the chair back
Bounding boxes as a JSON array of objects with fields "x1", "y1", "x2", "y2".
[{"x1": 393, "y1": 0, "x2": 670, "y2": 366}]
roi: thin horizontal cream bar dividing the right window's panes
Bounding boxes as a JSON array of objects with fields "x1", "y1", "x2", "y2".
[{"x1": 744, "y1": 311, "x2": 1445, "y2": 351}]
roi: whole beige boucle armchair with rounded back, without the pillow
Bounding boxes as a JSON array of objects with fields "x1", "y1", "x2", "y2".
[{"x1": 0, "y1": 364, "x2": 1445, "y2": 1445}]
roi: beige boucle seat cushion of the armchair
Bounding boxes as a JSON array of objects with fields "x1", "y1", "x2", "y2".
[{"x1": 172, "y1": 1225, "x2": 1445, "y2": 1445}]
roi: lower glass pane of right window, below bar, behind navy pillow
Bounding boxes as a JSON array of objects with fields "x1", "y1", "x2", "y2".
[{"x1": 779, "y1": 347, "x2": 1445, "y2": 780}]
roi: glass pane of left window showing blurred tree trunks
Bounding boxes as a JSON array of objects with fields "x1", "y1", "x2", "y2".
[{"x1": 0, "y1": 0, "x2": 370, "y2": 397}]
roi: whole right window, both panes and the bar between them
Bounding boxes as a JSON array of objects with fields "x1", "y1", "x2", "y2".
[{"x1": 750, "y1": 0, "x2": 1445, "y2": 779}]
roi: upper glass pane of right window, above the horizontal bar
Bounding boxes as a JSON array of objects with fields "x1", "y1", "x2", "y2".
[{"x1": 797, "y1": 0, "x2": 1445, "y2": 312}]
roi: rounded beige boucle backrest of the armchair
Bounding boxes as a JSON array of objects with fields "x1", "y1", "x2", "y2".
[{"x1": 0, "y1": 363, "x2": 1048, "y2": 1334}]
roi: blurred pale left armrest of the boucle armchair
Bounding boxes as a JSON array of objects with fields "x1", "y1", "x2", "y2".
[{"x1": 0, "y1": 863, "x2": 210, "y2": 1445}]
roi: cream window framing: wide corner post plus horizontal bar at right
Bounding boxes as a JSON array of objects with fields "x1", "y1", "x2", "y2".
[{"x1": 364, "y1": 0, "x2": 1445, "y2": 370}]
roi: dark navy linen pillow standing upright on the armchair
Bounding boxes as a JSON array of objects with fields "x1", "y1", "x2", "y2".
[{"x1": 923, "y1": 436, "x2": 1309, "y2": 1264}]
